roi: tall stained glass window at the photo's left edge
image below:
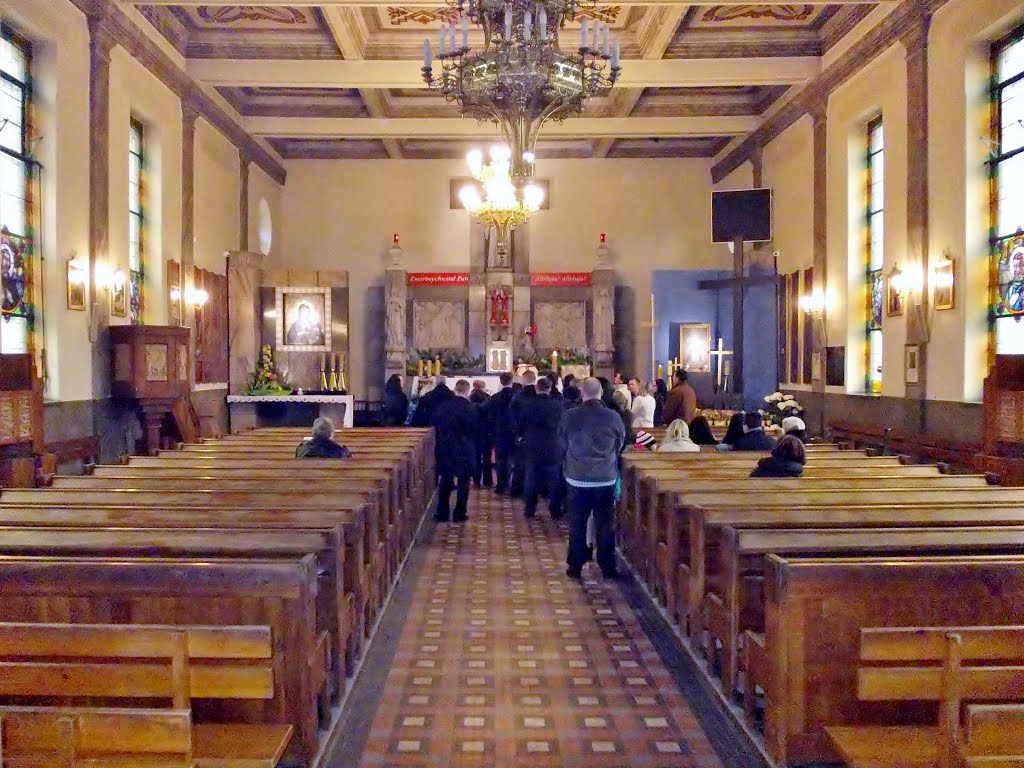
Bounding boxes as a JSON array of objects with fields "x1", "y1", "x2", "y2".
[{"x1": 0, "y1": 27, "x2": 34, "y2": 353}]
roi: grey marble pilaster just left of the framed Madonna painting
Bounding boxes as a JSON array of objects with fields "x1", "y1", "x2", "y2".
[{"x1": 227, "y1": 251, "x2": 263, "y2": 403}]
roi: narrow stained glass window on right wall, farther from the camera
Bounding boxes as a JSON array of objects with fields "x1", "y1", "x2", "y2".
[{"x1": 864, "y1": 117, "x2": 886, "y2": 394}]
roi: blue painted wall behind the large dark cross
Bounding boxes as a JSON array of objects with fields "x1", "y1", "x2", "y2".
[{"x1": 645, "y1": 269, "x2": 778, "y2": 409}]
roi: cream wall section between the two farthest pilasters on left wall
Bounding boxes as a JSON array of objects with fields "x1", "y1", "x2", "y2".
[{"x1": 195, "y1": 120, "x2": 241, "y2": 274}]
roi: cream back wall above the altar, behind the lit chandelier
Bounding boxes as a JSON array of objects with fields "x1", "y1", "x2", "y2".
[{"x1": 282, "y1": 160, "x2": 730, "y2": 396}]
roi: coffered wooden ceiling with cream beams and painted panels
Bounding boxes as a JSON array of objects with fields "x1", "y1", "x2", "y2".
[{"x1": 128, "y1": 0, "x2": 895, "y2": 159}]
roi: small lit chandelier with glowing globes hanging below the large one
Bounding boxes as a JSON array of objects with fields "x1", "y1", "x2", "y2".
[{"x1": 459, "y1": 144, "x2": 544, "y2": 267}]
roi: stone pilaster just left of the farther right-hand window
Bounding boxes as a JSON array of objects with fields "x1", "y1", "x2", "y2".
[{"x1": 804, "y1": 98, "x2": 828, "y2": 435}]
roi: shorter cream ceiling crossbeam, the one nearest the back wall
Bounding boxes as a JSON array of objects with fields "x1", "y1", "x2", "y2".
[{"x1": 245, "y1": 116, "x2": 760, "y2": 139}]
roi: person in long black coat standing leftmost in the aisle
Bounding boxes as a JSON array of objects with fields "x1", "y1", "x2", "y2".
[{"x1": 433, "y1": 379, "x2": 476, "y2": 522}]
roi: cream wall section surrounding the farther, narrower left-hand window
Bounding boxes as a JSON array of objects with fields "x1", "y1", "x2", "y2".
[{"x1": 110, "y1": 48, "x2": 181, "y2": 326}]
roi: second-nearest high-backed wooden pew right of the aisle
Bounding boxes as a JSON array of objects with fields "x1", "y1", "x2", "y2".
[{"x1": 698, "y1": 528, "x2": 1024, "y2": 700}]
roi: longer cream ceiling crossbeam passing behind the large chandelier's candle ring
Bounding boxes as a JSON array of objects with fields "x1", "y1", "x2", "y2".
[{"x1": 188, "y1": 56, "x2": 821, "y2": 88}]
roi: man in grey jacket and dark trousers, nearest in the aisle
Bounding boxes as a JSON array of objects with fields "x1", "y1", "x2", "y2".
[{"x1": 558, "y1": 379, "x2": 626, "y2": 579}]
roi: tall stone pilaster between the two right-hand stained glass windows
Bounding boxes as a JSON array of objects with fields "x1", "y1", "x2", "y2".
[{"x1": 901, "y1": 8, "x2": 932, "y2": 415}]
